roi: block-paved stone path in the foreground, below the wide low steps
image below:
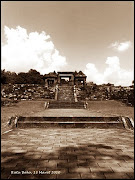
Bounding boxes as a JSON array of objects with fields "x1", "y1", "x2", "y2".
[{"x1": 1, "y1": 128, "x2": 134, "y2": 179}]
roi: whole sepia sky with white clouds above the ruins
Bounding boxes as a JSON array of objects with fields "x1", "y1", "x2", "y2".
[{"x1": 1, "y1": 1, "x2": 134, "y2": 86}]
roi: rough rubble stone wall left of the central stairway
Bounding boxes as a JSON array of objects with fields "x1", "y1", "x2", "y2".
[{"x1": 1, "y1": 84, "x2": 55, "y2": 105}]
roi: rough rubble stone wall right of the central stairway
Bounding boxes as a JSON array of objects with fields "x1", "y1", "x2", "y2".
[{"x1": 76, "y1": 85, "x2": 134, "y2": 106}]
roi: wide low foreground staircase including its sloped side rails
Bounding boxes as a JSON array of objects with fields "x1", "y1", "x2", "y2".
[{"x1": 8, "y1": 116, "x2": 134, "y2": 130}]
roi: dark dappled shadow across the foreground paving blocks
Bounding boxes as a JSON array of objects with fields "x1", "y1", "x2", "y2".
[{"x1": 1, "y1": 143, "x2": 134, "y2": 179}]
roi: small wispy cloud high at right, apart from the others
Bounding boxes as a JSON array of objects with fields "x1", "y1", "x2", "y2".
[{"x1": 109, "y1": 41, "x2": 132, "y2": 52}]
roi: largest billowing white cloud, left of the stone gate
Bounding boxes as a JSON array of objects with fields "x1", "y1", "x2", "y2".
[{"x1": 2, "y1": 26, "x2": 67, "y2": 74}]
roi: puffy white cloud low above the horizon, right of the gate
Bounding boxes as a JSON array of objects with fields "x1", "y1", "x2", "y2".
[{"x1": 84, "y1": 56, "x2": 134, "y2": 86}]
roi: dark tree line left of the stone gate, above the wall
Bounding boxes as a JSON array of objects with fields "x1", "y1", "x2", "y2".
[{"x1": 1, "y1": 69, "x2": 44, "y2": 84}]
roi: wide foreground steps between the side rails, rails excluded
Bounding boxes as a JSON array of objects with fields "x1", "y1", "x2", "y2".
[{"x1": 17, "y1": 117, "x2": 124, "y2": 129}]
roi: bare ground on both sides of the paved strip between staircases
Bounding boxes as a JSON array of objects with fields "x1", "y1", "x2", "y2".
[{"x1": 1, "y1": 100, "x2": 134, "y2": 133}]
